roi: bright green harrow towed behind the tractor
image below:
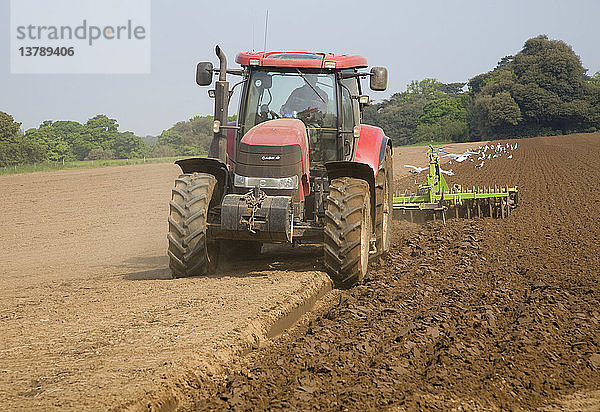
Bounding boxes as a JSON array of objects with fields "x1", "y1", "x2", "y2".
[{"x1": 393, "y1": 146, "x2": 519, "y2": 222}]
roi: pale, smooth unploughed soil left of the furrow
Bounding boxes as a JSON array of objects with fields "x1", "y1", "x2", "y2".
[{"x1": 0, "y1": 164, "x2": 329, "y2": 410}]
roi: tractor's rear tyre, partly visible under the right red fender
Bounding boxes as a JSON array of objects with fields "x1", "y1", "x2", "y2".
[{"x1": 375, "y1": 146, "x2": 394, "y2": 257}]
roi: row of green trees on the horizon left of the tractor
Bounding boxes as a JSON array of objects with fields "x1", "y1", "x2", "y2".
[{"x1": 0, "y1": 112, "x2": 220, "y2": 167}]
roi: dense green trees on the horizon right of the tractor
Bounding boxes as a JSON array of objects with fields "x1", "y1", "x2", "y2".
[{"x1": 363, "y1": 36, "x2": 600, "y2": 145}]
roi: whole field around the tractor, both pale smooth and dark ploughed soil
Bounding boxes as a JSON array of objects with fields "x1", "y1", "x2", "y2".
[{"x1": 0, "y1": 134, "x2": 600, "y2": 411}]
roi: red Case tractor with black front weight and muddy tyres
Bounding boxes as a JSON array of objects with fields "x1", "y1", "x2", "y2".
[{"x1": 168, "y1": 46, "x2": 392, "y2": 288}]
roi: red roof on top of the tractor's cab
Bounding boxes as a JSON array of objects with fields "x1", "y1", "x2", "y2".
[{"x1": 235, "y1": 52, "x2": 367, "y2": 69}]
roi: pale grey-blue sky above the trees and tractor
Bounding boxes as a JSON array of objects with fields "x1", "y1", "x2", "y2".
[{"x1": 0, "y1": 0, "x2": 600, "y2": 136}]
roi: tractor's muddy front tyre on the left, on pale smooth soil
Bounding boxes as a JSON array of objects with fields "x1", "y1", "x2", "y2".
[{"x1": 167, "y1": 173, "x2": 219, "y2": 278}]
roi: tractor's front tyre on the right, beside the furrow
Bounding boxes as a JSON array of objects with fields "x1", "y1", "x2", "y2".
[{"x1": 323, "y1": 177, "x2": 371, "y2": 288}]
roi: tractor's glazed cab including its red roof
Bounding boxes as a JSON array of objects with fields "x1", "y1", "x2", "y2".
[{"x1": 236, "y1": 52, "x2": 382, "y2": 169}]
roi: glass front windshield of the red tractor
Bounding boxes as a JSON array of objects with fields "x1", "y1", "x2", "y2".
[{"x1": 240, "y1": 69, "x2": 337, "y2": 163}]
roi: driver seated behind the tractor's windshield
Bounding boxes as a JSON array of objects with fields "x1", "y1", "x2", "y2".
[{"x1": 281, "y1": 74, "x2": 329, "y2": 123}]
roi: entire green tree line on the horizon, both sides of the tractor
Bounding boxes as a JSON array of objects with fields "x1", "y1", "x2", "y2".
[{"x1": 0, "y1": 36, "x2": 600, "y2": 166}]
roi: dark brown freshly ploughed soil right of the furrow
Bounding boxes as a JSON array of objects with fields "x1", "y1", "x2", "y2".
[{"x1": 193, "y1": 134, "x2": 600, "y2": 411}]
